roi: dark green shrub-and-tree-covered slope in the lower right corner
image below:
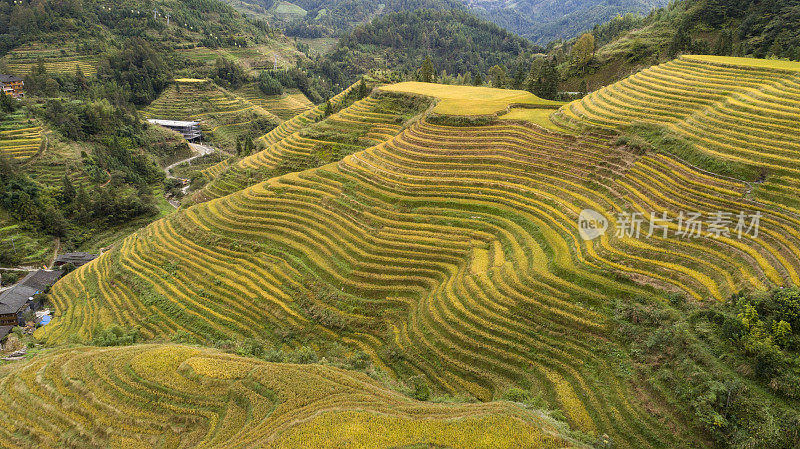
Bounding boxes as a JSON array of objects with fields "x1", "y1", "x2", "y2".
[{"x1": 615, "y1": 287, "x2": 800, "y2": 449}]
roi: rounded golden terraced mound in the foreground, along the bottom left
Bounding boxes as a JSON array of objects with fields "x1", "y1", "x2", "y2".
[{"x1": 0, "y1": 345, "x2": 575, "y2": 449}]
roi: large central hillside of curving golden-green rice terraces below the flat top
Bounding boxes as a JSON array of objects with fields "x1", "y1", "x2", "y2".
[{"x1": 37, "y1": 77, "x2": 800, "y2": 449}]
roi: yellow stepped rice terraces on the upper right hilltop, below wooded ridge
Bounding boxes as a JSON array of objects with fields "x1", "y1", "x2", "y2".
[{"x1": 553, "y1": 56, "x2": 800, "y2": 213}]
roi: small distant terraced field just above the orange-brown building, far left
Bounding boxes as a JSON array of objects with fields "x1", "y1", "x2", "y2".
[{"x1": 0, "y1": 42, "x2": 97, "y2": 77}]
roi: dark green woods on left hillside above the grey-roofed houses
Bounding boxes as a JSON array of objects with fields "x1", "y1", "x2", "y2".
[{"x1": 0, "y1": 38, "x2": 185, "y2": 254}]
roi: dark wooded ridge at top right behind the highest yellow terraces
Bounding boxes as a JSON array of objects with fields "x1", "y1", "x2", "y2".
[{"x1": 550, "y1": 0, "x2": 800, "y2": 88}]
